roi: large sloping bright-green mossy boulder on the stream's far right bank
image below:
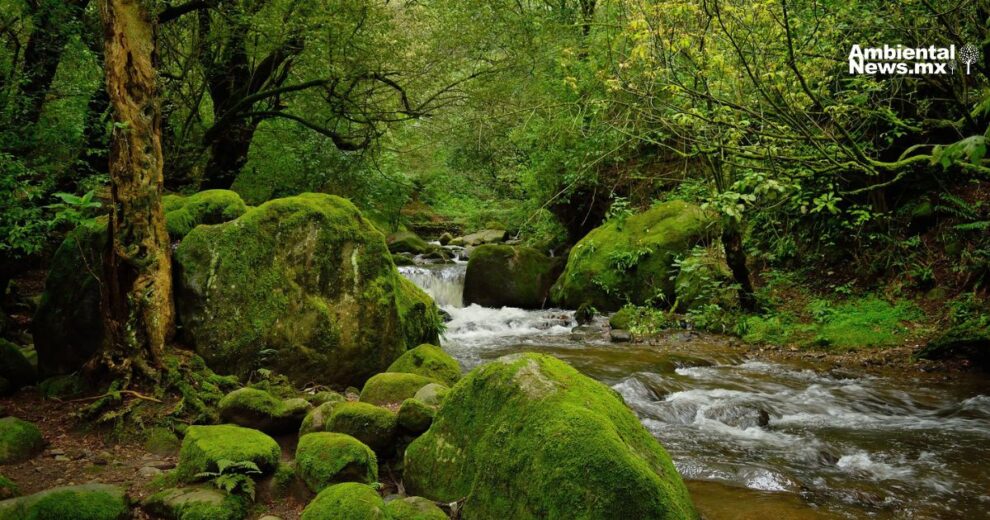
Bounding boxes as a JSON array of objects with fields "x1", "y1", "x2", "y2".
[{"x1": 551, "y1": 201, "x2": 713, "y2": 311}]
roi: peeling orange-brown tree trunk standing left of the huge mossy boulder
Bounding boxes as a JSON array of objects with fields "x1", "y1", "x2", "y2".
[{"x1": 91, "y1": 0, "x2": 175, "y2": 385}]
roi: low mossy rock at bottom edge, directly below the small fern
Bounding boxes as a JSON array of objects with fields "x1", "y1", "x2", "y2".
[{"x1": 141, "y1": 486, "x2": 248, "y2": 520}]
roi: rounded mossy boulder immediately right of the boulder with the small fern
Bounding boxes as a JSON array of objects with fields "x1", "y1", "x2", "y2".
[{"x1": 296, "y1": 432, "x2": 378, "y2": 493}]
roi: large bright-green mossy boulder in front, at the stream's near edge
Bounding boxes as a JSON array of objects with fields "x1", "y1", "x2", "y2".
[{"x1": 403, "y1": 354, "x2": 698, "y2": 519}]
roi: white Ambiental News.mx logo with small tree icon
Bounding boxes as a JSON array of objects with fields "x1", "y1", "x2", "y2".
[{"x1": 849, "y1": 44, "x2": 980, "y2": 75}]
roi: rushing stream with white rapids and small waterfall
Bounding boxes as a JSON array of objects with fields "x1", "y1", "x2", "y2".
[{"x1": 400, "y1": 263, "x2": 990, "y2": 520}]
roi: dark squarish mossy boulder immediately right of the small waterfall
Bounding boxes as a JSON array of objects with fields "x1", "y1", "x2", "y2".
[{"x1": 464, "y1": 245, "x2": 562, "y2": 309}]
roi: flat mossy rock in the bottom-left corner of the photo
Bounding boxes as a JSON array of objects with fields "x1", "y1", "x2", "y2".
[{"x1": 0, "y1": 484, "x2": 131, "y2": 520}]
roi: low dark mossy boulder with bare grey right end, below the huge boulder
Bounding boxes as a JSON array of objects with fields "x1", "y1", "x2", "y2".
[{"x1": 219, "y1": 388, "x2": 313, "y2": 434}]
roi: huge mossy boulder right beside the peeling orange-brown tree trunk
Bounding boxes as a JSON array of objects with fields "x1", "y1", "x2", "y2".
[{"x1": 175, "y1": 193, "x2": 441, "y2": 386}]
